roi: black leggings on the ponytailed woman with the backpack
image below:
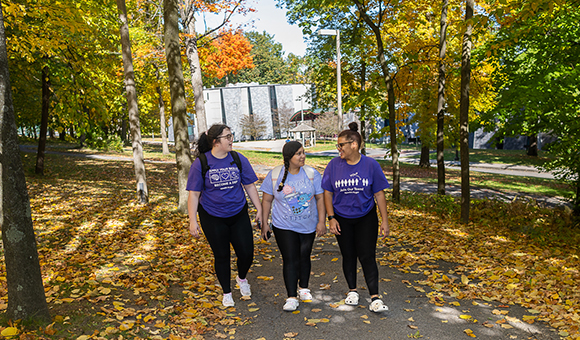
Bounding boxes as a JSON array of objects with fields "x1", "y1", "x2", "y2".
[{"x1": 197, "y1": 204, "x2": 254, "y2": 294}]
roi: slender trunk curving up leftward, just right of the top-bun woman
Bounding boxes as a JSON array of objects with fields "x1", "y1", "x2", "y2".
[{"x1": 354, "y1": 0, "x2": 401, "y2": 203}]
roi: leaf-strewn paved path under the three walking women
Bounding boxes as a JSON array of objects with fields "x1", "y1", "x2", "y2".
[{"x1": 216, "y1": 236, "x2": 559, "y2": 340}]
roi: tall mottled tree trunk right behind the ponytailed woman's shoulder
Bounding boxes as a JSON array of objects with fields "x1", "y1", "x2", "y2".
[{"x1": 163, "y1": 0, "x2": 193, "y2": 213}]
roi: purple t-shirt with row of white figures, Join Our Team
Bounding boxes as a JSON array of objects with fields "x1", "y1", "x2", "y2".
[{"x1": 322, "y1": 155, "x2": 389, "y2": 218}]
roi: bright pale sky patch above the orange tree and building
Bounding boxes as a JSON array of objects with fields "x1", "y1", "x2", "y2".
[{"x1": 196, "y1": 0, "x2": 306, "y2": 56}]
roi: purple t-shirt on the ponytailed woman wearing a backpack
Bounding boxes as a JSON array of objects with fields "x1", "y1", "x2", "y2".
[{"x1": 186, "y1": 151, "x2": 258, "y2": 217}]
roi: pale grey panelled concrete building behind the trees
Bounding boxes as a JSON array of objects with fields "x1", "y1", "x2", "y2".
[{"x1": 168, "y1": 83, "x2": 311, "y2": 141}]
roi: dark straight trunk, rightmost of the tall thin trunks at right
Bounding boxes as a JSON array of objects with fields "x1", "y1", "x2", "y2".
[{"x1": 459, "y1": 0, "x2": 474, "y2": 223}]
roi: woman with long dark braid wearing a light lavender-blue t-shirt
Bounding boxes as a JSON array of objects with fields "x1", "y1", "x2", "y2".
[{"x1": 260, "y1": 141, "x2": 326, "y2": 311}]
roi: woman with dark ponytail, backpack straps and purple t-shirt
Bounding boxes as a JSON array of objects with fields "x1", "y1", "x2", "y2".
[{"x1": 186, "y1": 124, "x2": 262, "y2": 307}]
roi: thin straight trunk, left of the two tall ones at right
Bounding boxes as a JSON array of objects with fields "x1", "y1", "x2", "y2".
[{"x1": 437, "y1": 0, "x2": 449, "y2": 195}]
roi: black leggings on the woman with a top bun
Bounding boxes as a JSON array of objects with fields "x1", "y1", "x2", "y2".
[{"x1": 335, "y1": 207, "x2": 379, "y2": 296}]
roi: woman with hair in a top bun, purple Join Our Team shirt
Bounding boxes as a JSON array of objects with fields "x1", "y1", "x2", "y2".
[{"x1": 322, "y1": 122, "x2": 389, "y2": 312}]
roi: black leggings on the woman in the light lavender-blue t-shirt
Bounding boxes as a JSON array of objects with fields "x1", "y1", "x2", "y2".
[{"x1": 272, "y1": 226, "x2": 316, "y2": 297}]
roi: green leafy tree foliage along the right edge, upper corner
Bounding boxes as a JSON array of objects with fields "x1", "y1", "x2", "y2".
[{"x1": 483, "y1": 0, "x2": 580, "y2": 216}]
